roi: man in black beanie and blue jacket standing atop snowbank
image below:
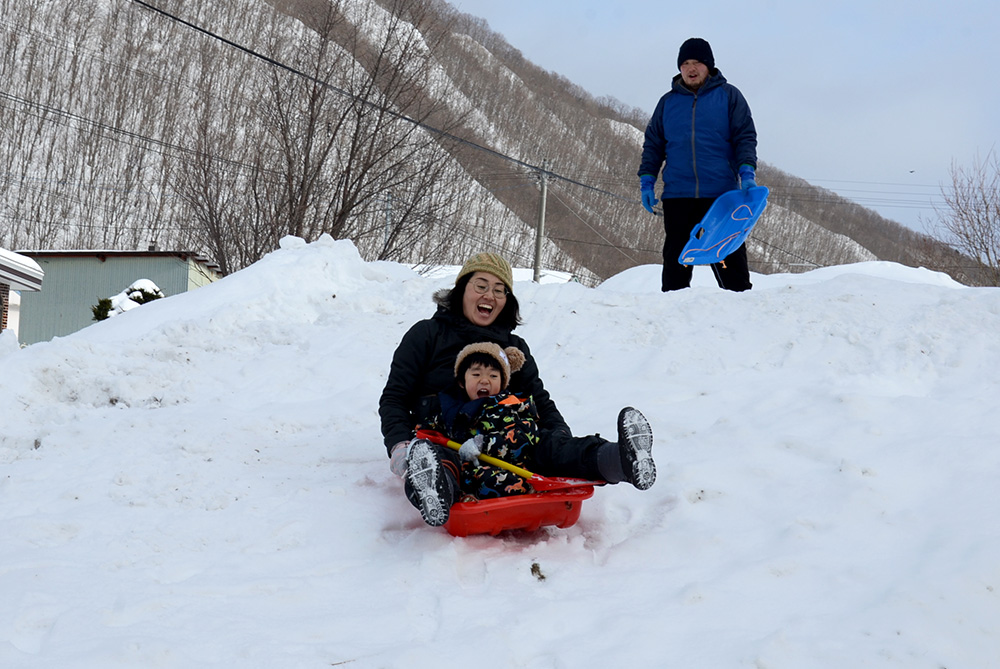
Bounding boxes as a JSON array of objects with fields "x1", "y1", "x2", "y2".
[{"x1": 638, "y1": 37, "x2": 757, "y2": 292}]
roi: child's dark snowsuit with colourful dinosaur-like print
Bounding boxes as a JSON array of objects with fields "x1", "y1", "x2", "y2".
[{"x1": 435, "y1": 392, "x2": 539, "y2": 499}]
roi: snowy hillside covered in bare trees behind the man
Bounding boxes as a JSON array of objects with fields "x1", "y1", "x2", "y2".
[{"x1": 0, "y1": 0, "x2": 957, "y2": 283}]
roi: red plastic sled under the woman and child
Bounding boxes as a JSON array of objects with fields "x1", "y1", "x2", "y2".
[{"x1": 444, "y1": 486, "x2": 594, "y2": 537}]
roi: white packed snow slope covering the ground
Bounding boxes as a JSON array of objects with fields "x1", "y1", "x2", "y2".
[{"x1": 0, "y1": 238, "x2": 1000, "y2": 669}]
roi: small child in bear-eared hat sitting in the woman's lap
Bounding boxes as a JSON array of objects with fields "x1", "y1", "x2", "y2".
[{"x1": 433, "y1": 342, "x2": 539, "y2": 499}]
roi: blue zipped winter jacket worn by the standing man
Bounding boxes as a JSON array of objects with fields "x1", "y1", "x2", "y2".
[{"x1": 638, "y1": 70, "x2": 757, "y2": 198}]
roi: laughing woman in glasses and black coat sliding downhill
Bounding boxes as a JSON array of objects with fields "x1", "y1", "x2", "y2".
[{"x1": 379, "y1": 253, "x2": 656, "y2": 526}]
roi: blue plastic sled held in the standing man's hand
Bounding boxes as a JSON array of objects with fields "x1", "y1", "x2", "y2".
[{"x1": 677, "y1": 186, "x2": 768, "y2": 265}]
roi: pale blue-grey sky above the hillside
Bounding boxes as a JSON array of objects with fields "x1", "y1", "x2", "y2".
[{"x1": 449, "y1": 0, "x2": 1000, "y2": 231}]
